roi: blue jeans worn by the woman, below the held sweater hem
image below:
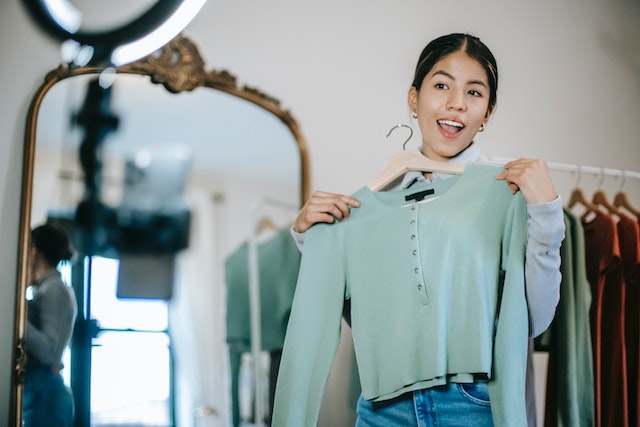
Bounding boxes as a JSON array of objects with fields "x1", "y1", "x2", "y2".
[{"x1": 356, "y1": 382, "x2": 493, "y2": 427}]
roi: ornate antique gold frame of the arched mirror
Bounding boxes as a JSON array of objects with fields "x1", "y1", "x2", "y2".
[{"x1": 10, "y1": 35, "x2": 309, "y2": 426}]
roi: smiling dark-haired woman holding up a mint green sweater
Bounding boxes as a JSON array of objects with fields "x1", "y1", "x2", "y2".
[{"x1": 274, "y1": 34, "x2": 564, "y2": 426}]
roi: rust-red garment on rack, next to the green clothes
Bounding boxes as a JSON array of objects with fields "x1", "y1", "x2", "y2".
[{"x1": 583, "y1": 210, "x2": 629, "y2": 427}]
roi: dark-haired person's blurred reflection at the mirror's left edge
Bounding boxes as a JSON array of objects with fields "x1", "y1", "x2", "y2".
[{"x1": 23, "y1": 223, "x2": 77, "y2": 427}]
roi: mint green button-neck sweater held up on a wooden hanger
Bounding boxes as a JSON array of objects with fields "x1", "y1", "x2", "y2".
[{"x1": 273, "y1": 163, "x2": 528, "y2": 427}]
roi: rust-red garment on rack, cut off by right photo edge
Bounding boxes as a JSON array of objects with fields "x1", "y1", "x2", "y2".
[{"x1": 618, "y1": 214, "x2": 640, "y2": 427}]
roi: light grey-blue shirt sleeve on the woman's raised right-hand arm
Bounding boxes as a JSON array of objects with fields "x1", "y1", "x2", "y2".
[{"x1": 525, "y1": 197, "x2": 565, "y2": 337}]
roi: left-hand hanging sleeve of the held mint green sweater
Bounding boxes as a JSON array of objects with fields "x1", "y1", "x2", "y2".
[{"x1": 273, "y1": 225, "x2": 345, "y2": 427}]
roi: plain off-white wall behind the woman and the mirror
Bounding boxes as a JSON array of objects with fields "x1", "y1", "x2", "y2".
[{"x1": 0, "y1": 0, "x2": 640, "y2": 424}]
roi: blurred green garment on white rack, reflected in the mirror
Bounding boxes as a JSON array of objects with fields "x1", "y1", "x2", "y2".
[{"x1": 225, "y1": 229, "x2": 300, "y2": 426}]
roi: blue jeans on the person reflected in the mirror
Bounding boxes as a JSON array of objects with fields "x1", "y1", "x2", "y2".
[{"x1": 22, "y1": 367, "x2": 74, "y2": 427}]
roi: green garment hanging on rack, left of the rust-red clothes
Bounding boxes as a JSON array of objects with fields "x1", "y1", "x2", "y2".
[{"x1": 535, "y1": 209, "x2": 595, "y2": 427}]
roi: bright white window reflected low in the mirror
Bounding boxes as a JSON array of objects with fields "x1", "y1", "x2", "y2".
[{"x1": 90, "y1": 257, "x2": 172, "y2": 427}]
